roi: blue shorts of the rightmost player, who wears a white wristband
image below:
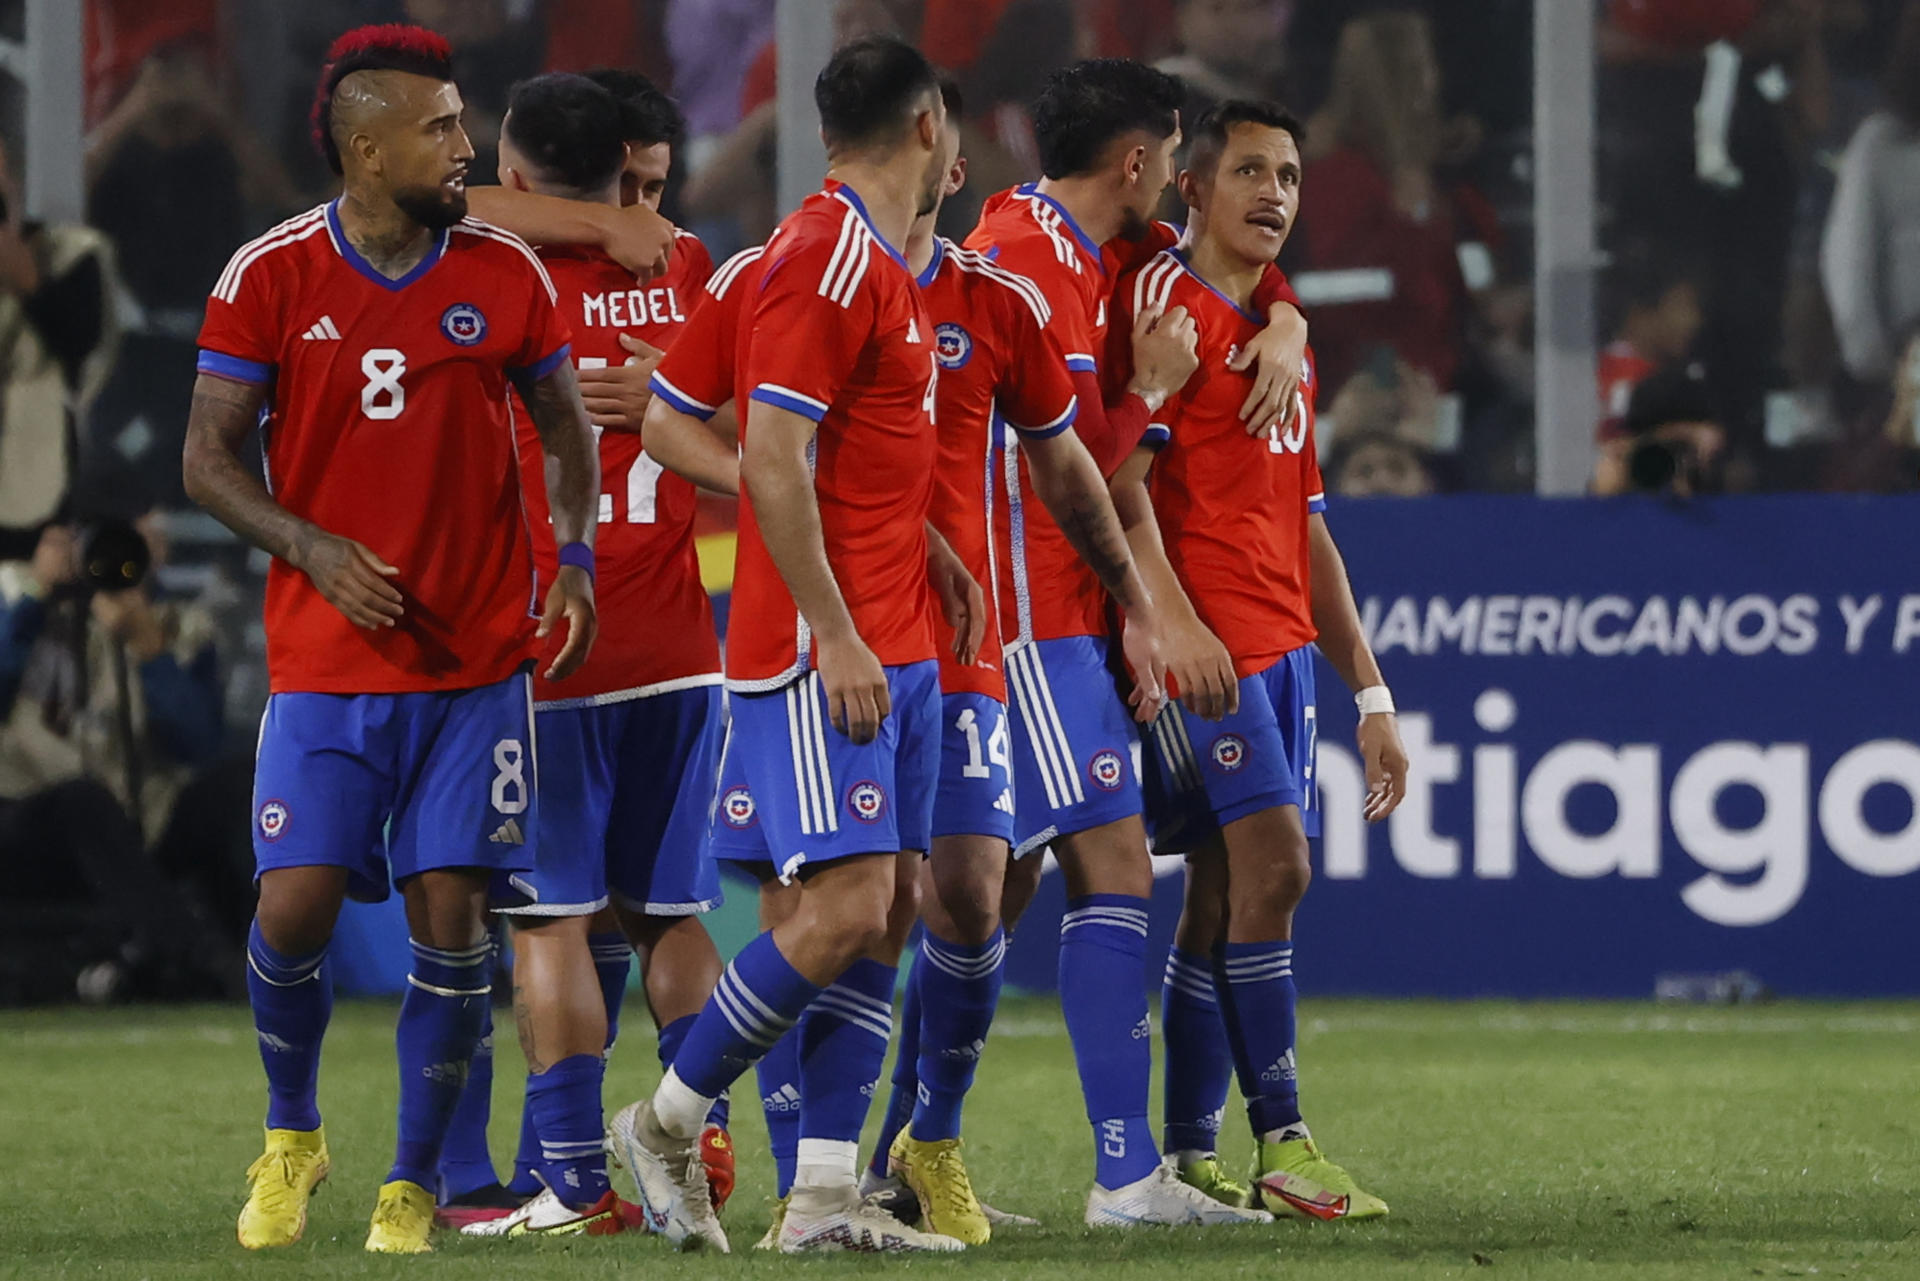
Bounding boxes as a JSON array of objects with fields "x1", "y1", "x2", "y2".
[{"x1": 1146, "y1": 645, "x2": 1319, "y2": 855}]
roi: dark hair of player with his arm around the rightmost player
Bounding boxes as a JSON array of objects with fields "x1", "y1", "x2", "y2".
[{"x1": 1033, "y1": 58, "x2": 1187, "y2": 179}]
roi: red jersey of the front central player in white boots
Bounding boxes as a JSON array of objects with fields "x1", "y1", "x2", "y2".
[{"x1": 721, "y1": 181, "x2": 939, "y2": 693}]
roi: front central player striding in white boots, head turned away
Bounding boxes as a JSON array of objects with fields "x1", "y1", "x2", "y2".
[{"x1": 612, "y1": 38, "x2": 966, "y2": 1252}]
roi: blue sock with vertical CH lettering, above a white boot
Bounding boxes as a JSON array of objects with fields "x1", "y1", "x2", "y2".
[{"x1": 1060, "y1": 895, "x2": 1160, "y2": 1189}]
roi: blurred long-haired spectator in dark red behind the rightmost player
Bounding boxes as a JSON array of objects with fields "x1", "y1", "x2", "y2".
[{"x1": 1290, "y1": 10, "x2": 1498, "y2": 390}]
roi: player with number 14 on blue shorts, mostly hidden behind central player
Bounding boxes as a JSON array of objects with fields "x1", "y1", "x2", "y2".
[{"x1": 862, "y1": 85, "x2": 1182, "y2": 1245}]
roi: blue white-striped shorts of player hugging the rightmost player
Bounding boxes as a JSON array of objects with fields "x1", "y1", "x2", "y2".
[{"x1": 1006, "y1": 636, "x2": 1140, "y2": 858}]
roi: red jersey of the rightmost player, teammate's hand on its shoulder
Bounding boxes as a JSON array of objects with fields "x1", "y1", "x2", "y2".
[{"x1": 1114, "y1": 250, "x2": 1327, "y2": 676}]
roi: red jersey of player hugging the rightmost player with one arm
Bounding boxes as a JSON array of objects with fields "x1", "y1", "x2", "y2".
[{"x1": 966, "y1": 182, "x2": 1112, "y2": 645}]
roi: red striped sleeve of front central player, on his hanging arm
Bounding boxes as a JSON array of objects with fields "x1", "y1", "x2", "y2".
[{"x1": 741, "y1": 240, "x2": 879, "y2": 423}]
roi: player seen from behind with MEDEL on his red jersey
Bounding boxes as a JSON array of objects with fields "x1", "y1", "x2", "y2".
[{"x1": 420, "y1": 75, "x2": 720, "y2": 1237}]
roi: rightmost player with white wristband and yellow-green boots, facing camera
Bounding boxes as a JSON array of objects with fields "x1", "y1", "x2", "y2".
[{"x1": 1110, "y1": 102, "x2": 1407, "y2": 1220}]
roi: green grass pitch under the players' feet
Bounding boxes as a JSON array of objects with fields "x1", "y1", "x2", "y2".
[{"x1": 0, "y1": 1001, "x2": 1920, "y2": 1281}]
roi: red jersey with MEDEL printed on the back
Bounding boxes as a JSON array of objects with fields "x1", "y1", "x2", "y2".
[{"x1": 516, "y1": 232, "x2": 720, "y2": 707}]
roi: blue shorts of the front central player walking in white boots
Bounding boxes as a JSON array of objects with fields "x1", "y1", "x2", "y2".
[{"x1": 712, "y1": 659, "x2": 941, "y2": 880}]
